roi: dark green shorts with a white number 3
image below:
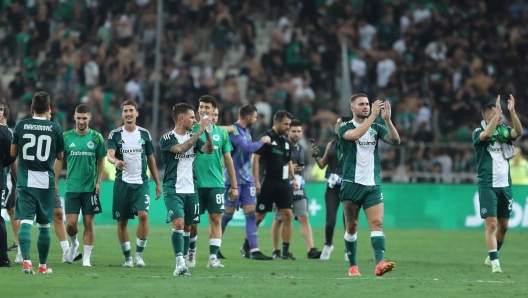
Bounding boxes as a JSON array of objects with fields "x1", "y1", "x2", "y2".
[{"x1": 112, "y1": 180, "x2": 150, "y2": 220}]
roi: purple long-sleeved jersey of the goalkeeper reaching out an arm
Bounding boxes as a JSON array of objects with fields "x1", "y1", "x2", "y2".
[{"x1": 225, "y1": 123, "x2": 263, "y2": 185}]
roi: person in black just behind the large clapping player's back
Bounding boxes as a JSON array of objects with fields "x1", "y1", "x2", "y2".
[{"x1": 312, "y1": 117, "x2": 352, "y2": 260}]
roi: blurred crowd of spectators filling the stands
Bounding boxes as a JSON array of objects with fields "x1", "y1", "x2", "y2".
[{"x1": 0, "y1": 0, "x2": 528, "y2": 184}]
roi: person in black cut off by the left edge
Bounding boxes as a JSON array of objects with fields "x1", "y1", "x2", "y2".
[{"x1": 0, "y1": 103, "x2": 16, "y2": 267}]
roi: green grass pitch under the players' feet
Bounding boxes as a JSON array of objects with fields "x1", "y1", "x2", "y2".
[{"x1": 0, "y1": 225, "x2": 528, "y2": 298}]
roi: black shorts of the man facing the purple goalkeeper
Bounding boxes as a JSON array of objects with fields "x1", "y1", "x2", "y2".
[{"x1": 256, "y1": 183, "x2": 293, "y2": 213}]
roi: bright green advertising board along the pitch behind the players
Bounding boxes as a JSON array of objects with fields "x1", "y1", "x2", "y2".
[{"x1": 4, "y1": 181, "x2": 528, "y2": 230}]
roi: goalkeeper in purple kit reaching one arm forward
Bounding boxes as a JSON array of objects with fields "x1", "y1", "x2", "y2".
[{"x1": 222, "y1": 104, "x2": 271, "y2": 261}]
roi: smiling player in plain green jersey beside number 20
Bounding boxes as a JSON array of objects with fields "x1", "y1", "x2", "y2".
[{"x1": 55, "y1": 104, "x2": 106, "y2": 267}]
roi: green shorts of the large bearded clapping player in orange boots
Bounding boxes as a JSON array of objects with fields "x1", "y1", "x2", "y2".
[{"x1": 339, "y1": 181, "x2": 383, "y2": 209}]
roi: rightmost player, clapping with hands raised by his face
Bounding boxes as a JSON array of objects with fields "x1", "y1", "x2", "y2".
[{"x1": 473, "y1": 94, "x2": 523, "y2": 273}]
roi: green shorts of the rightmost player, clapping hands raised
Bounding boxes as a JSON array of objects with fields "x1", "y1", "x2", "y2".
[{"x1": 479, "y1": 186, "x2": 513, "y2": 218}]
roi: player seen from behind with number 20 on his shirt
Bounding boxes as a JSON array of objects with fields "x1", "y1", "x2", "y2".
[{"x1": 11, "y1": 92, "x2": 64, "y2": 274}]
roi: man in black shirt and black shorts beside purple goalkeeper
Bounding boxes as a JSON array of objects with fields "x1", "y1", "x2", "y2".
[{"x1": 252, "y1": 111, "x2": 299, "y2": 260}]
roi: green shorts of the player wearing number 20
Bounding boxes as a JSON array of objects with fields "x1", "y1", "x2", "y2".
[{"x1": 15, "y1": 186, "x2": 55, "y2": 225}]
